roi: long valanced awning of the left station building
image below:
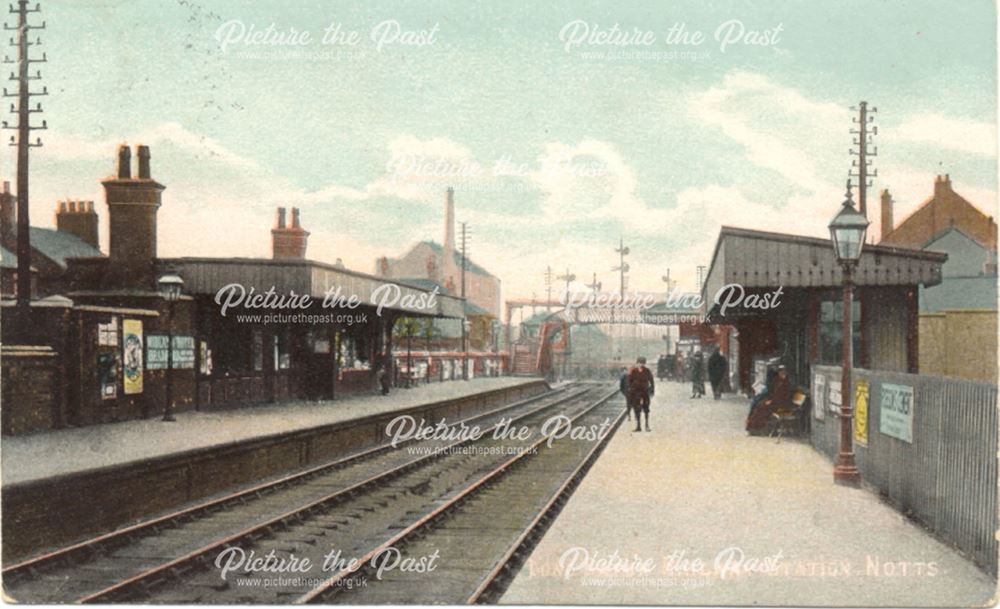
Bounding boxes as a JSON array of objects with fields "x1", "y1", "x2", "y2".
[{"x1": 158, "y1": 258, "x2": 463, "y2": 318}]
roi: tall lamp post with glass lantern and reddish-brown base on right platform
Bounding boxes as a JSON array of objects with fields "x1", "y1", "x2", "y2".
[{"x1": 829, "y1": 181, "x2": 868, "y2": 486}]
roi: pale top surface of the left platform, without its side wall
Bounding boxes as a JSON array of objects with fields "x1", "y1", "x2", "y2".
[{"x1": 0, "y1": 377, "x2": 537, "y2": 485}]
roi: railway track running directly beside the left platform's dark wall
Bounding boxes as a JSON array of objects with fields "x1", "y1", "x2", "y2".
[{"x1": 3, "y1": 387, "x2": 600, "y2": 602}]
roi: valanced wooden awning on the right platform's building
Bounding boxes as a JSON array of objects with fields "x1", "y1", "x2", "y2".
[{"x1": 702, "y1": 226, "x2": 948, "y2": 302}]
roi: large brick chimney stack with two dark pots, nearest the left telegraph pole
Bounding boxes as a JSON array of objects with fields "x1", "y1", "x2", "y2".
[{"x1": 101, "y1": 144, "x2": 166, "y2": 290}]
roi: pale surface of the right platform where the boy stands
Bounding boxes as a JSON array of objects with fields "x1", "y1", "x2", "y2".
[{"x1": 501, "y1": 383, "x2": 996, "y2": 607}]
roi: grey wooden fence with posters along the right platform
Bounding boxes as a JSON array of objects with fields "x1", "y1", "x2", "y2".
[{"x1": 810, "y1": 366, "x2": 997, "y2": 577}]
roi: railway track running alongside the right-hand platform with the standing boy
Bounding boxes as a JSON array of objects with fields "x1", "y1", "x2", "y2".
[{"x1": 294, "y1": 384, "x2": 625, "y2": 605}]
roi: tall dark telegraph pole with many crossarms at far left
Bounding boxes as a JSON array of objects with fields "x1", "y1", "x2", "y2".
[{"x1": 2, "y1": 0, "x2": 49, "y2": 320}]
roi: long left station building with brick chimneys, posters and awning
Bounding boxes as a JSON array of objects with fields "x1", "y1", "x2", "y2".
[{"x1": 0, "y1": 145, "x2": 463, "y2": 434}]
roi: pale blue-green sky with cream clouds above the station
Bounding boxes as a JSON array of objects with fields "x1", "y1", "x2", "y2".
[{"x1": 0, "y1": 0, "x2": 997, "y2": 298}]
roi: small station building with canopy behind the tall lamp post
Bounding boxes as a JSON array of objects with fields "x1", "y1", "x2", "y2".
[{"x1": 702, "y1": 226, "x2": 948, "y2": 390}]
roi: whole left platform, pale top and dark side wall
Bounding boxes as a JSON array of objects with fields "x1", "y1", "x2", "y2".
[{"x1": 2, "y1": 377, "x2": 550, "y2": 562}]
